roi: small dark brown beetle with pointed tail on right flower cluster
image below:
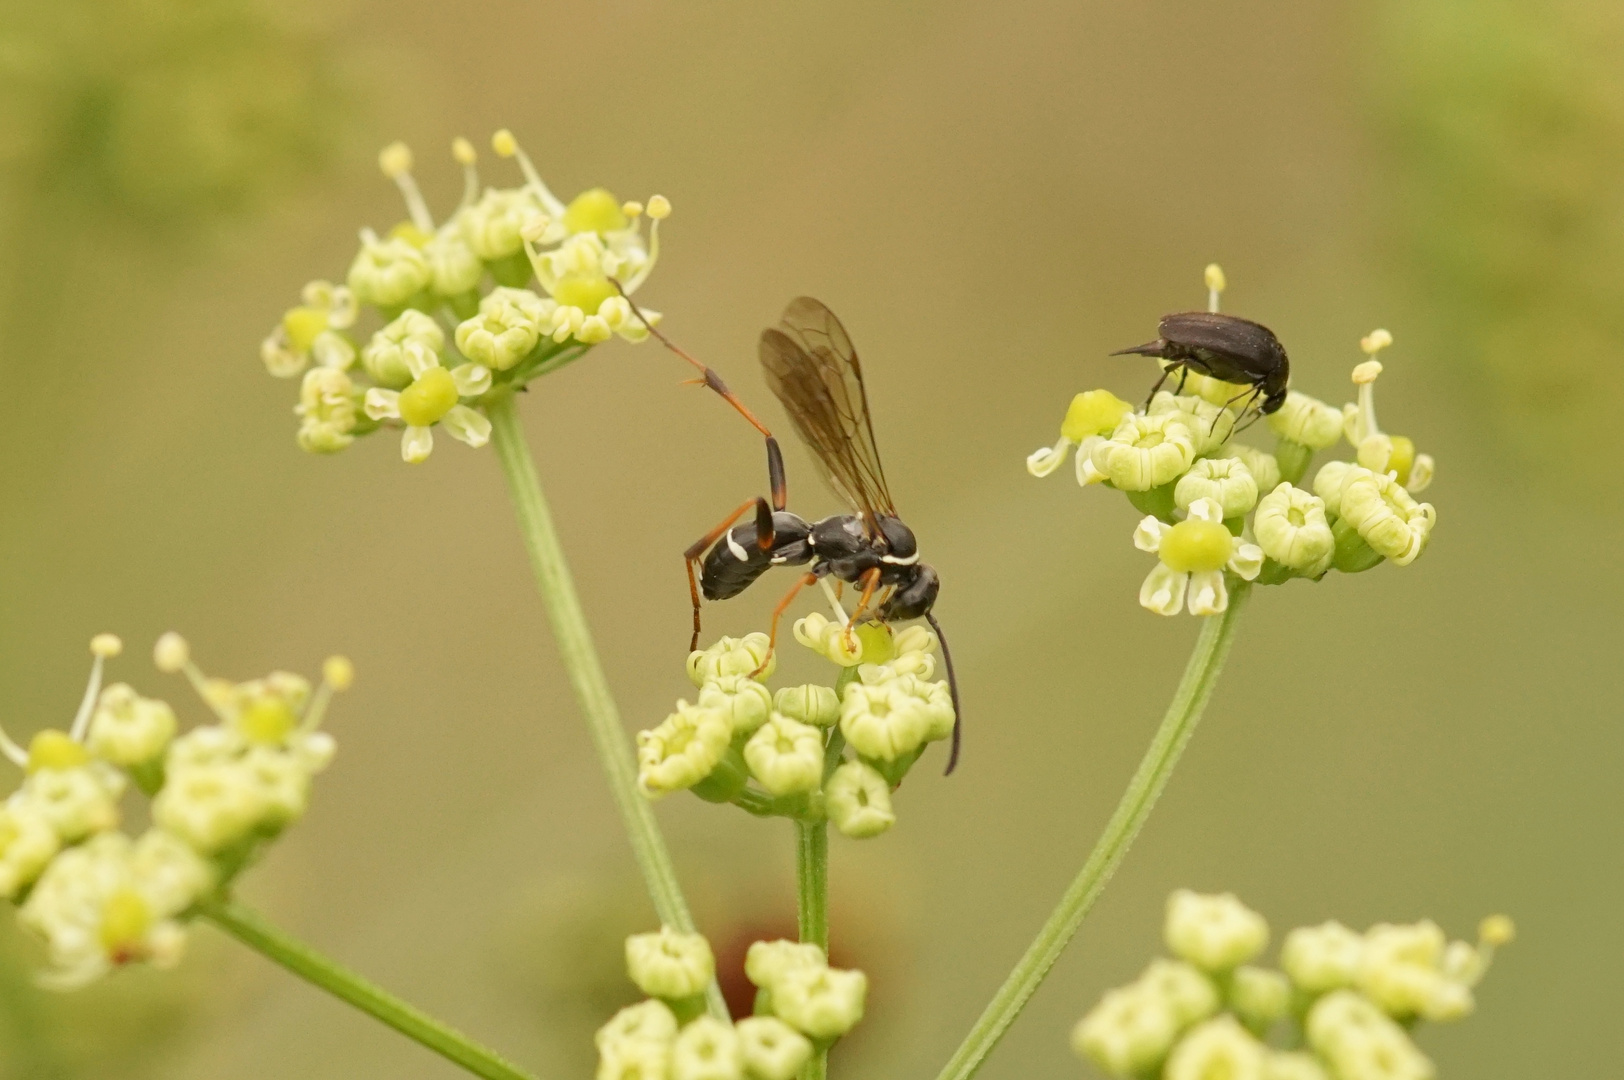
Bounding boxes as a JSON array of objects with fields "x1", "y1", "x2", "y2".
[{"x1": 1111, "y1": 312, "x2": 1291, "y2": 414}]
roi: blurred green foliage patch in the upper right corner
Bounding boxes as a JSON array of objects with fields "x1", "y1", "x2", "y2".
[{"x1": 1374, "y1": 0, "x2": 1624, "y2": 479}]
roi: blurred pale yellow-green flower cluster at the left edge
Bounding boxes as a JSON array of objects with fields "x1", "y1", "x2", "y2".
[{"x1": 0, "y1": 633, "x2": 351, "y2": 989}]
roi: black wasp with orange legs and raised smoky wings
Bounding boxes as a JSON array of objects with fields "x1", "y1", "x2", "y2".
[{"x1": 613, "y1": 296, "x2": 963, "y2": 773}]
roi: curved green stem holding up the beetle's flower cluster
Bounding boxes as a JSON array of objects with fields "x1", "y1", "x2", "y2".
[{"x1": 937, "y1": 577, "x2": 1252, "y2": 1080}]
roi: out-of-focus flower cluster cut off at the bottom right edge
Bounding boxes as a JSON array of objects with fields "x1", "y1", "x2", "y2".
[{"x1": 1072, "y1": 890, "x2": 1512, "y2": 1080}]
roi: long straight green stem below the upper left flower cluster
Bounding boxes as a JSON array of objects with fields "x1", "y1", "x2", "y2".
[{"x1": 486, "y1": 393, "x2": 728, "y2": 1020}]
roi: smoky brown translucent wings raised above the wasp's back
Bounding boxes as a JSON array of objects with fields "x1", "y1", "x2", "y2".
[{"x1": 760, "y1": 296, "x2": 896, "y2": 534}]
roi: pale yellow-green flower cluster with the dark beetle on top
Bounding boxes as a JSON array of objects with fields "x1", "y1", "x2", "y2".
[{"x1": 1026, "y1": 268, "x2": 1437, "y2": 616}]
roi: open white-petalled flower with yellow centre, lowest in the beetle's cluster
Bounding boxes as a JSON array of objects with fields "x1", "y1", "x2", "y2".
[{"x1": 1134, "y1": 499, "x2": 1263, "y2": 616}]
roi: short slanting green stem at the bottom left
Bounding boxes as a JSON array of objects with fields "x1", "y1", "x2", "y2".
[{"x1": 197, "y1": 898, "x2": 536, "y2": 1080}]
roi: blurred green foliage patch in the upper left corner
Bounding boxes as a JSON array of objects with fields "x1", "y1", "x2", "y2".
[{"x1": 0, "y1": 0, "x2": 336, "y2": 235}]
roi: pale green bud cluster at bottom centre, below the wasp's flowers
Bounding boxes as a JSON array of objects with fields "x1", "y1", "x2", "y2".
[{"x1": 598, "y1": 929, "x2": 869, "y2": 1080}]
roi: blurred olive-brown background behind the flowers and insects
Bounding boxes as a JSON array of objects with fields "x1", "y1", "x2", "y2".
[{"x1": 0, "y1": 0, "x2": 1624, "y2": 1080}]
